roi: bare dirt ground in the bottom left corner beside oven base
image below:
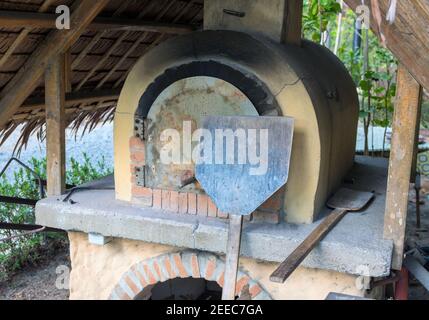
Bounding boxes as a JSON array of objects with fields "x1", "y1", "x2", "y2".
[{"x1": 0, "y1": 249, "x2": 70, "y2": 300}]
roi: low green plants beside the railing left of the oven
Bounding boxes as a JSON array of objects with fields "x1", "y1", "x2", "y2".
[{"x1": 0, "y1": 153, "x2": 112, "y2": 282}]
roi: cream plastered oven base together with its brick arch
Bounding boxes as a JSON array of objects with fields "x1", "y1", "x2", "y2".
[{"x1": 69, "y1": 232, "x2": 364, "y2": 300}]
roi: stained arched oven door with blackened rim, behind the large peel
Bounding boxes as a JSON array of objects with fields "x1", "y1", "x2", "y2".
[{"x1": 135, "y1": 61, "x2": 280, "y2": 193}]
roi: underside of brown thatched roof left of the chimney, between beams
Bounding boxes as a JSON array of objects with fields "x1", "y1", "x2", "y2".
[{"x1": 0, "y1": 0, "x2": 203, "y2": 152}]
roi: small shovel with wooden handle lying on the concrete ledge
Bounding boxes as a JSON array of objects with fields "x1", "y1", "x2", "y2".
[{"x1": 270, "y1": 188, "x2": 374, "y2": 283}]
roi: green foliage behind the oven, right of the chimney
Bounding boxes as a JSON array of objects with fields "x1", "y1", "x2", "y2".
[{"x1": 303, "y1": 0, "x2": 398, "y2": 155}]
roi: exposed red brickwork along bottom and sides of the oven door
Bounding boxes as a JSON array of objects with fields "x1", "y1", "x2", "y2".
[{"x1": 130, "y1": 137, "x2": 284, "y2": 223}]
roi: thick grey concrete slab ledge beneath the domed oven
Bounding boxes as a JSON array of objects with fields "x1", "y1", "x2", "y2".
[{"x1": 36, "y1": 157, "x2": 392, "y2": 277}]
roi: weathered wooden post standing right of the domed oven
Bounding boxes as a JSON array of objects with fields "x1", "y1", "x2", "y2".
[{"x1": 384, "y1": 65, "x2": 421, "y2": 270}]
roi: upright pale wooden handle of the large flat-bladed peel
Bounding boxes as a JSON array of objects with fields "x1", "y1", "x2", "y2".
[{"x1": 222, "y1": 215, "x2": 243, "y2": 300}]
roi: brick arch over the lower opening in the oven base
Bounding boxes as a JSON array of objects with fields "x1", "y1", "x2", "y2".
[{"x1": 109, "y1": 250, "x2": 271, "y2": 300}]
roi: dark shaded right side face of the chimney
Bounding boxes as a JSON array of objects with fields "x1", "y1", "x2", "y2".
[{"x1": 282, "y1": 0, "x2": 303, "y2": 46}]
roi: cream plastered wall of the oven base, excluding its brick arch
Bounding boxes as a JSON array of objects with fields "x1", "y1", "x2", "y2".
[{"x1": 69, "y1": 232, "x2": 364, "y2": 300}]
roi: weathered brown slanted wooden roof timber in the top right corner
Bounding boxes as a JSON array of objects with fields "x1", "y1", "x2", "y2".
[{"x1": 344, "y1": 0, "x2": 429, "y2": 90}]
